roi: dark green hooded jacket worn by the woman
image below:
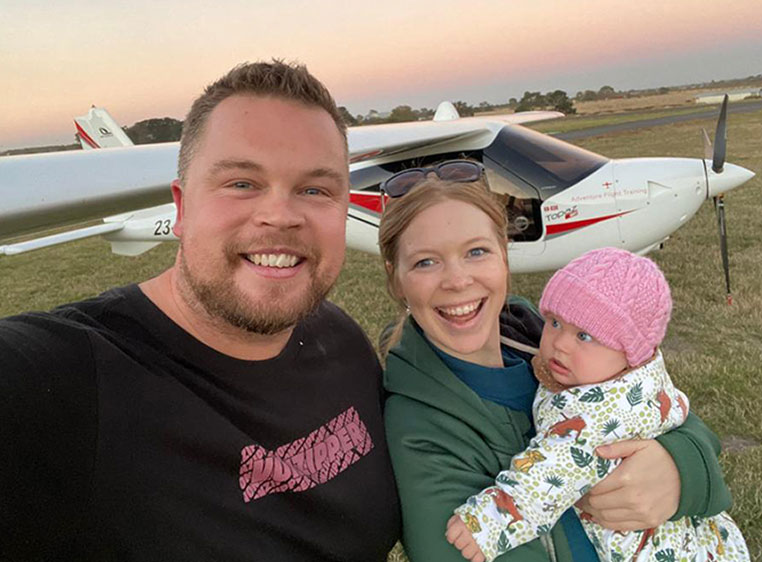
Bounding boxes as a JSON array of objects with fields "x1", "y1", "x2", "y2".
[{"x1": 384, "y1": 297, "x2": 730, "y2": 562}]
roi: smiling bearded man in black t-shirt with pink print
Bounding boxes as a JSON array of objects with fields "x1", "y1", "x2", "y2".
[{"x1": 0, "y1": 61, "x2": 399, "y2": 561}]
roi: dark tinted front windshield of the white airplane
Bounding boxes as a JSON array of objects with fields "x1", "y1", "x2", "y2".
[{"x1": 484, "y1": 125, "x2": 608, "y2": 201}]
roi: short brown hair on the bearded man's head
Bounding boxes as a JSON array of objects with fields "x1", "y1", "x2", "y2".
[{"x1": 177, "y1": 59, "x2": 347, "y2": 183}]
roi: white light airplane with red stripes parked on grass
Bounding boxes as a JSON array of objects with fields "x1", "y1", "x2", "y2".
[{"x1": 0, "y1": 102, "x2": 754, "y2": 293}]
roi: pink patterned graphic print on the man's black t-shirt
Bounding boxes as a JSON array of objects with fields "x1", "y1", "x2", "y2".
[{"x1": 238, "y1": 408, "x2": 373, "y2": 502}]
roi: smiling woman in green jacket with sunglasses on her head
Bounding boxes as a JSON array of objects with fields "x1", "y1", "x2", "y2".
[{"x1": 379, "y1": 161, "x2": 730, "y2": 562}]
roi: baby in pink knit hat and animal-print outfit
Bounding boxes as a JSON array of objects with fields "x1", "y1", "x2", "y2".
[{"x1": 447, "y1": 248, "x2": 749, "y2": 562}]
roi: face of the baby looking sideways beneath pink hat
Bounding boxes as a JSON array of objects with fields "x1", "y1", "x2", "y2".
[{"x1": 540, "y1": 315, "x2": 628, "y2": 386}]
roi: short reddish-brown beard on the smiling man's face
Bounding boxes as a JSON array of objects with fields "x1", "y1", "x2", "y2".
[{"x1": 180, "y1": 236, "x2": 336, "y2": 335}]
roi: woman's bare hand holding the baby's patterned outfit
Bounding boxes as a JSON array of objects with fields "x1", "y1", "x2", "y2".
[{"x1": 576, "y1": 439, "x2": 680, "y2": 531}]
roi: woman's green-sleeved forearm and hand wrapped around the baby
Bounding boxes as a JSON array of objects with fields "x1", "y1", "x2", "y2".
[{"x1": 577, "y1": 414, "x2": 731, "y2": 531}]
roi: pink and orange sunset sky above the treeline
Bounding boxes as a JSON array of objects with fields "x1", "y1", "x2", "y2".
[{"x1": 0, "y1": 0, "x2": 762, "y2": 150}]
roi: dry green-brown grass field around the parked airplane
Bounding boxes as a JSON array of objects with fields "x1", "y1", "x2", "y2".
[{"x1": 0, "y1": 107, "x2": 762, "y2": 562}]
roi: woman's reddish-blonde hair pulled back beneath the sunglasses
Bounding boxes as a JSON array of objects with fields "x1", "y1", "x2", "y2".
[{"x1": 378, "y1": 177, "x2": 510, "y2": 357}]
